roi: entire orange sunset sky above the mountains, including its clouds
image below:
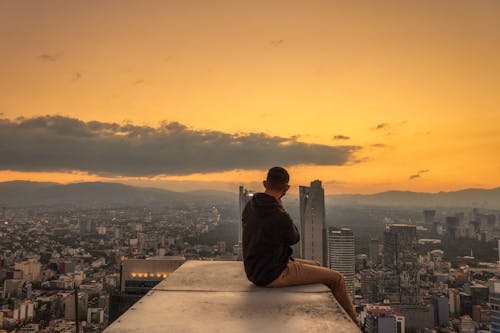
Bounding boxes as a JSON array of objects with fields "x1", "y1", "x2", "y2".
[{"x1": 0, "y1": 0, "x2": 500, "y2": 194}]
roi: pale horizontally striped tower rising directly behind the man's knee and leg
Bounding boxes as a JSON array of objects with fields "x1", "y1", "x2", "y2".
[{"x1": 327, "y1": 227, "x2": 355, "y2": 296}]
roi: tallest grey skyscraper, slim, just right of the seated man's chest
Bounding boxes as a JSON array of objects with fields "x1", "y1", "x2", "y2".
[{"x1": 299, "y1": 180, "x2": 326, "y2": 266}]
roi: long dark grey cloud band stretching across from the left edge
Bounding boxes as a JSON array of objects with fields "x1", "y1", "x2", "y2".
[{"x1": 0, "y1": 116, "x2": 360, "y2": 176}]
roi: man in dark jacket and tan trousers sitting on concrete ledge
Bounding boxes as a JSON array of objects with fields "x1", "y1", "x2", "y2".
[{"x1": 242, "y1": 167, "x2": 358, "y2": 323}]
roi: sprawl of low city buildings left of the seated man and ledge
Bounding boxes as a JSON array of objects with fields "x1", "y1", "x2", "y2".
[{"x1": 0, "y1": 198, "x2": 234, "y2": 332}]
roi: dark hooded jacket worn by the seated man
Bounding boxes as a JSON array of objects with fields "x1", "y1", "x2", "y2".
[{"x1": 242, "y1": 193, "x2": 299, "y2": 286}]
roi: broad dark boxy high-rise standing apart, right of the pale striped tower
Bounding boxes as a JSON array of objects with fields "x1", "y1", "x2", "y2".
[{"x1": 384, "y1": 224, "x2": 420, "y2": 304}]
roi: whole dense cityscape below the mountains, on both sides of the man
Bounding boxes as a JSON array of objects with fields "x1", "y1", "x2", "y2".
[{"x1": 0, "y1": 181, "x2": 500, "y2": 333}]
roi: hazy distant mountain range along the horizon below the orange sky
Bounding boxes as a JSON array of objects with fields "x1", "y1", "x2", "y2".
[{"x1": 0, "y1": 181, "x2": 500, "y2": 209}]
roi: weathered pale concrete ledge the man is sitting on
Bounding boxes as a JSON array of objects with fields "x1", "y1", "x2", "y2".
[{"x1": 105, "y1": 261, "x2": 360, "y2": 333}]
